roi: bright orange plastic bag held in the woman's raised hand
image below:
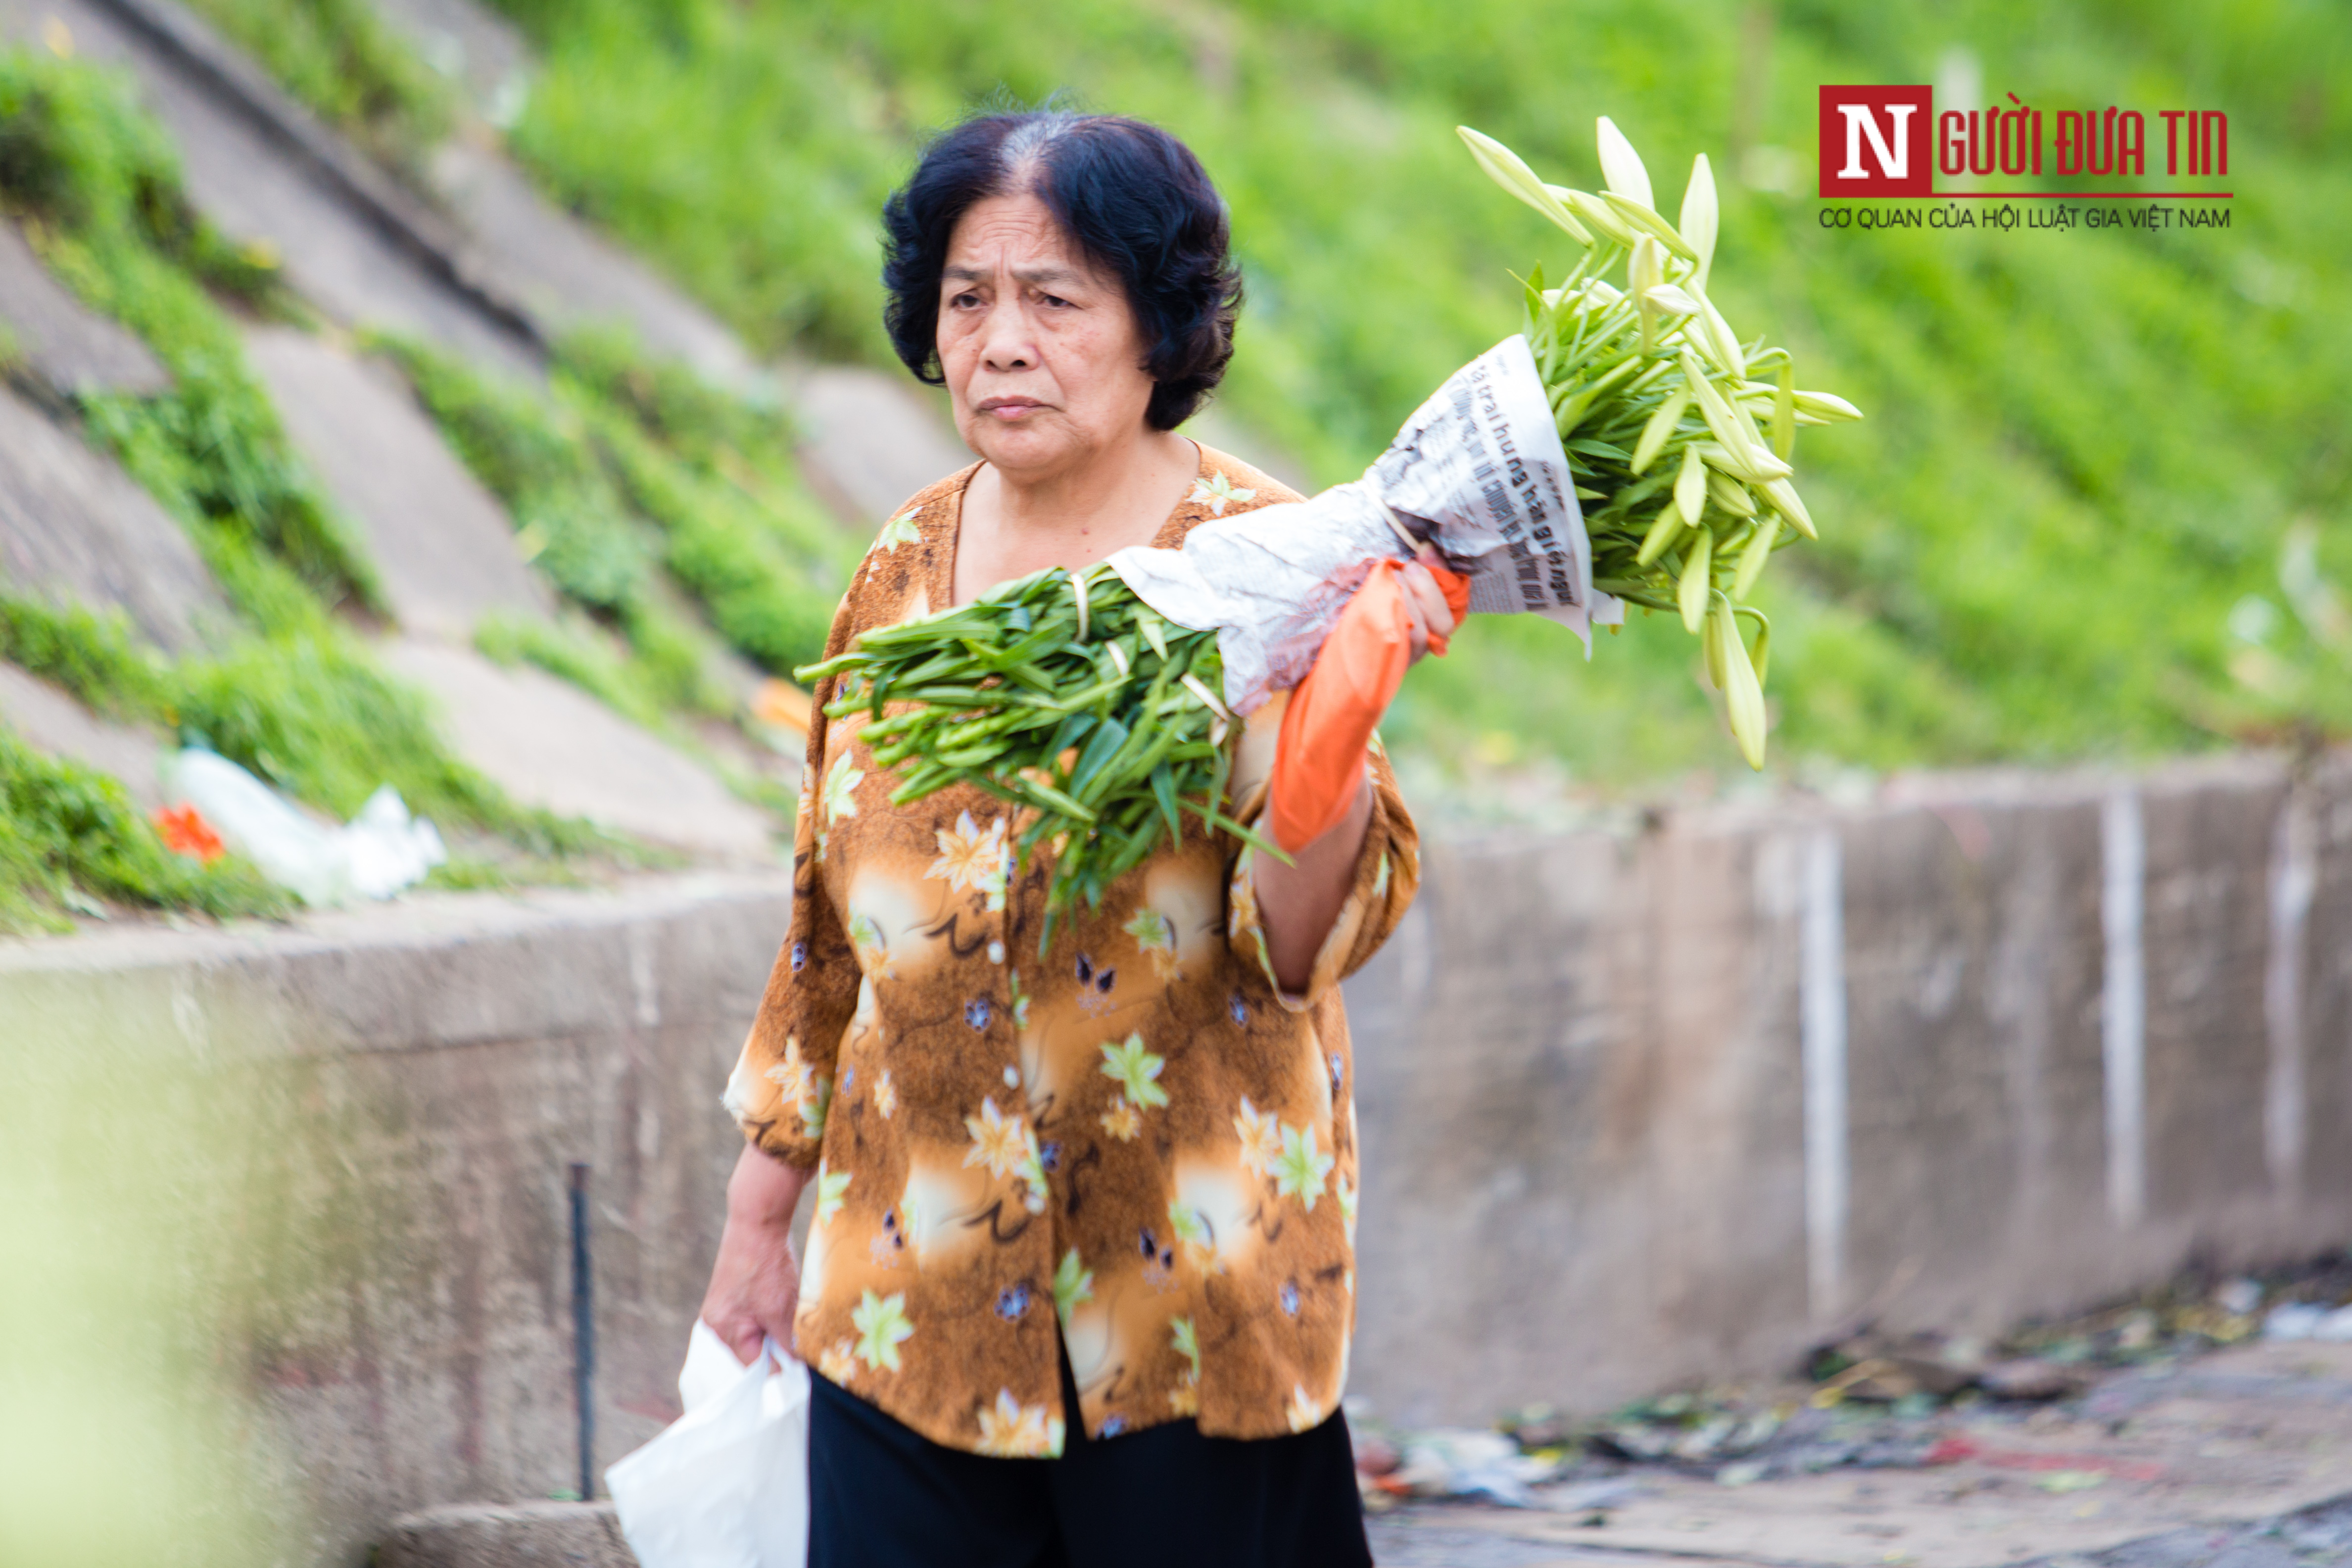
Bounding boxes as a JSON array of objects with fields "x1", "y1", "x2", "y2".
[{"x1": 1265, "y1": 562, "x2": 1470, "y2": 855}]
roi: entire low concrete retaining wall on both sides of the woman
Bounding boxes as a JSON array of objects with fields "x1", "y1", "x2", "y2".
[{"x1": 0, "y1": 760, "x2": 2352, "y2": 1559}]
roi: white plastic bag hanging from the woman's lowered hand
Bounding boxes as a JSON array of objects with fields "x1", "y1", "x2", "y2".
[{"x1": 605, "y1": 1321, "x2": 809, "y2": 1568}]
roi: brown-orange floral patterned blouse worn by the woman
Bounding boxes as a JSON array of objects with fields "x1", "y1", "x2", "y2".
[{"x1": 727, "y1": 447, "x2": 1421, "y2": 1455}]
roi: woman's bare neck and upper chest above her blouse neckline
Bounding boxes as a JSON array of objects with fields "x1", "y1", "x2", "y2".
[{"x1": 955, "y1": 430, "x2": 1200, "y2": 604}]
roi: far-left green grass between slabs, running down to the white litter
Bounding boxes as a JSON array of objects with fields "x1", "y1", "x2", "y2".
[{"x1": 0, "y1": 52, "x2": 605, "y2": 931}]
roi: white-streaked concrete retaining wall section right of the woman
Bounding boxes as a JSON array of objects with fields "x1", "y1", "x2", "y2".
[{"x1": 1347, "y1": 760, "x2": 2352, "y2": 1422}]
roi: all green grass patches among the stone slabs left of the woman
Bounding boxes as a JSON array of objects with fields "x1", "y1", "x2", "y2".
[{"x1": 0, "y1": 21, "x2": 884, "y2": 929}]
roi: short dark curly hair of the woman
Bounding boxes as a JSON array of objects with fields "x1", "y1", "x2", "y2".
[{"x1": 882, "y1": 108, "x2": 1242, "y2": 430}]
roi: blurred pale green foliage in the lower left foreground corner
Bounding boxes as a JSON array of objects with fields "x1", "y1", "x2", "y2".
[{"x1": 0, "y1": 992, "x2": 305, "y2": 1568}]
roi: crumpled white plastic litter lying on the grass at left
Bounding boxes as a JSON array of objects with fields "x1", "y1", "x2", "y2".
[{"x1": 162, "y1": 748, "x2": 449, "y2": 905}]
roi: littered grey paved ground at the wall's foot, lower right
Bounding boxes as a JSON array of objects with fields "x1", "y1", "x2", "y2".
[{"x1": 1374, "y1": 1345, "x2": 2352, "y2": 1568}]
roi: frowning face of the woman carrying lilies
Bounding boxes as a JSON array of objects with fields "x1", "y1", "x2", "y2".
[{"x1": 938, "y1": 193, "x2": 1152, "y2": 477}]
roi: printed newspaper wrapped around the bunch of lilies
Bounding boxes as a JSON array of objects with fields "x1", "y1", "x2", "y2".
[{"x1": 1110, "y1": 334, "x2": 1625, "y2": 713}]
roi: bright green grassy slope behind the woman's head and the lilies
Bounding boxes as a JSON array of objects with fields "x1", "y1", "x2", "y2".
[{"x1": 482, "y1": 0, "x2": 2352, "y2": 778}]
